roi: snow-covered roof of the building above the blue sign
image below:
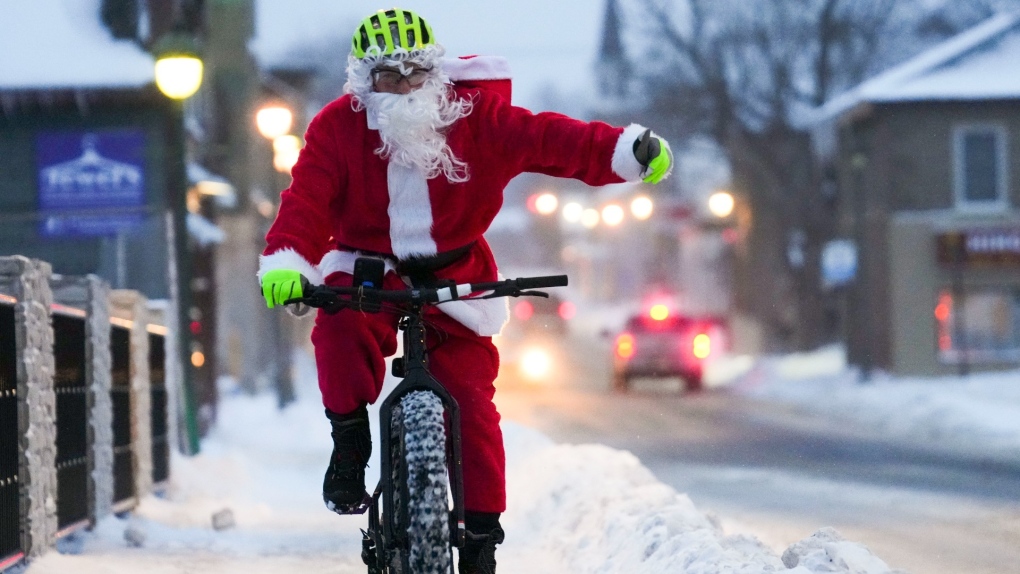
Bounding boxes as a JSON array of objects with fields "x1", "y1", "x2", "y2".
[{"x1": 0, "y1": 0, "x2": 155, "y2": 91}]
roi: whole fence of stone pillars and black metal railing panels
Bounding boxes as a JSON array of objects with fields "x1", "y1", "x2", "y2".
[{"x1": 0, "y1": 256, "x2": 172, "y2": 571}]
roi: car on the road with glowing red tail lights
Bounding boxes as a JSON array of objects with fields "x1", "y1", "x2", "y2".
[{"x1": 613, "y1": 305, "x2": 729, "y2": 393}]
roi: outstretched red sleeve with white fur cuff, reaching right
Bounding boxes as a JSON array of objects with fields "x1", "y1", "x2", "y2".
[{"x1": 472, "y1": 89, "x2": 641, "y2": 186}]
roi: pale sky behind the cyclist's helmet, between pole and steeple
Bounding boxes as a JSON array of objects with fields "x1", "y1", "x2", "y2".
[{"x1": 252, "y1": 0, "x2": 605, "y2": 106}]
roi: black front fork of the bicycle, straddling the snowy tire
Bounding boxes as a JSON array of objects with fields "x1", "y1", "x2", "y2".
[{"x1": 366, "y1": 303, "x2": 466, "y2": 570}]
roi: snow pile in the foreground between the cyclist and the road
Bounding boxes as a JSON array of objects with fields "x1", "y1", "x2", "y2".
[{"x1": 498, "y1": 423, "x2": 894, "y2": 574}]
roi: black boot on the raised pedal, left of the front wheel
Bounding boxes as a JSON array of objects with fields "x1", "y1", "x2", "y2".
[{"x1": 322, "y1": 406, "x2": 372, "y2": 514}]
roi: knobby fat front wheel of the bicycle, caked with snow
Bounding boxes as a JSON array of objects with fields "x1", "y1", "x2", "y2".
[{"x1": 390, "y1": 390, "x2": 451, "y2": 574}]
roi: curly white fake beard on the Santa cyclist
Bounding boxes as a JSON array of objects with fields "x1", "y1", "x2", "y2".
[{"x1": 364, "y1": 79, "x2": 470, "y2": 182}]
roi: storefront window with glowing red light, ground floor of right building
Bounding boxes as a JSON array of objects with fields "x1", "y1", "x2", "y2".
[{"x1": 934, "y1": 289, "x2": 1020, "y2": 363}]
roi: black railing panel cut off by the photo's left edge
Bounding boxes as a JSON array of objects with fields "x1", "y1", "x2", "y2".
[{"x1": 0, "y1": 301, "x2": 21, "y2": 568}]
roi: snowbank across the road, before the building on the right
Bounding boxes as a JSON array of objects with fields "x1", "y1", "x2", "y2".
[{"x1": 716, "y1": 347, "x2": 1020, "y2": 465}]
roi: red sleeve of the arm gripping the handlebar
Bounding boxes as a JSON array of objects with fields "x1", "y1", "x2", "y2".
[{"x1": 260, "y1": 101, "x2": 346, "y2": 281}]
